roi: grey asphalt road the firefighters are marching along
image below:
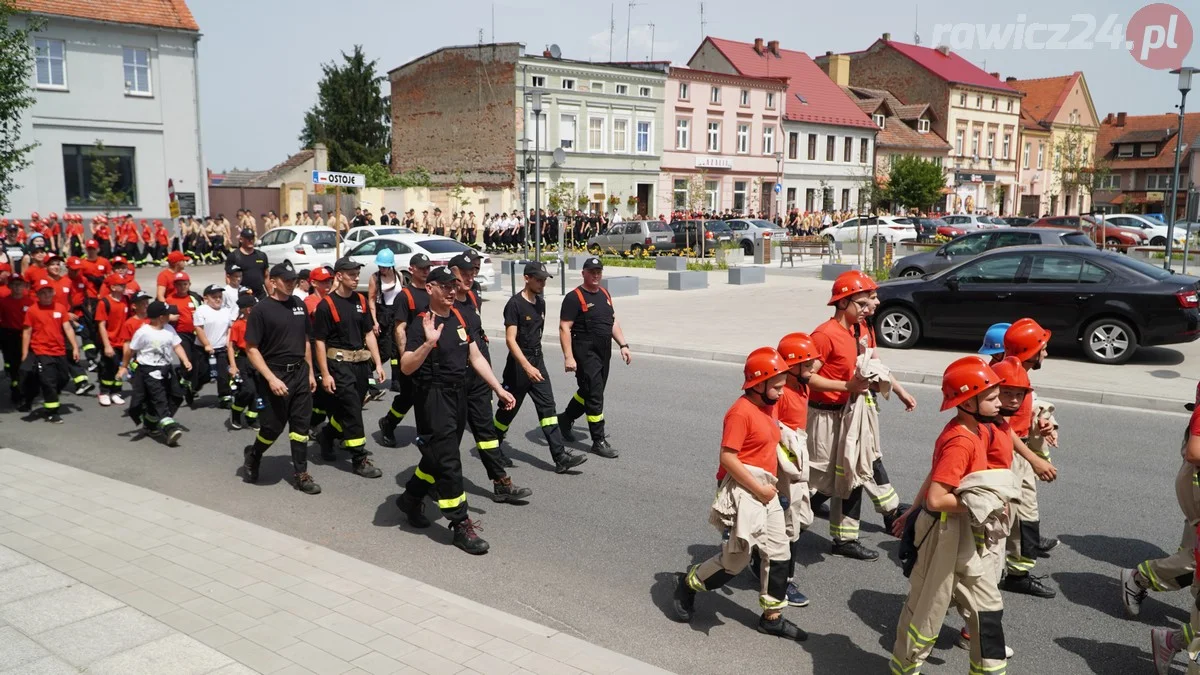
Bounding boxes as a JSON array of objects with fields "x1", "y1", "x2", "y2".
[{"x1": 0, "y1": 345, "x2": 1190, "y2": 675}]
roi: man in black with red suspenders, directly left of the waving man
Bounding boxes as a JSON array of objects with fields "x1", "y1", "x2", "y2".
[{"x1": 312, "y1": 257, "x2": 383, "y2": 478}]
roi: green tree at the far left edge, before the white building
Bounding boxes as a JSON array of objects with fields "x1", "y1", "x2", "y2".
[{"x1": 0, "y1": 0, "x2": 43, "y2": 214}]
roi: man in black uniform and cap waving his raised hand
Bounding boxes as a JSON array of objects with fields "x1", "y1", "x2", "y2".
[{"x1": 396, "y1": 267, "x2": 514, "y2": 555}]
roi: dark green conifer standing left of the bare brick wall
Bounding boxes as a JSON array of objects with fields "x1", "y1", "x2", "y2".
[{"x1": 300, "y1": 44, "x2": 391, "y2": 171}]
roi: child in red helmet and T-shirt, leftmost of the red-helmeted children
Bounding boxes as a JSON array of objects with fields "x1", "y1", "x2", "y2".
[{"x1": 673, "y1": 347, "x2": 808, "y2": 640}]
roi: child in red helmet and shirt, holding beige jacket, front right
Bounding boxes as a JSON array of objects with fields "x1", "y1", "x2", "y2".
[{"x1": 890, "y1": 356, "x2": 1015, "y2": 675}]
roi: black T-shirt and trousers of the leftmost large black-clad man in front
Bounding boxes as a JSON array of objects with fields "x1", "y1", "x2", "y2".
[{"x1": 246, "y1": 295, "x2": 312, "y2": 474}]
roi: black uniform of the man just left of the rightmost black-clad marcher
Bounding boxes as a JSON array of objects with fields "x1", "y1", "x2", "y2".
[{"x1": 493, "y1": 293, "x2": 566, "y2": 464}]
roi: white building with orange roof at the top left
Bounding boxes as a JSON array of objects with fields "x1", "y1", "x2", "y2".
[{"x1": 4, "y1": 0, "x2": 208, "y2": 220}]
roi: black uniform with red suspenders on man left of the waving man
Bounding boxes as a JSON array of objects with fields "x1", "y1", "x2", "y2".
[{"x1": 312, "y1": 292, "x2": 374, "y2": 464}]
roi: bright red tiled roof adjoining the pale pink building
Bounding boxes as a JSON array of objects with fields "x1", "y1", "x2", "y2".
[{"x1": 696, "y1": 37, "x2": 877, "y2": 129}]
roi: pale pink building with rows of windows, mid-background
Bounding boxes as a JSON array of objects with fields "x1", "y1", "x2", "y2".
[{"x1": 656, "y1": 67, "x2": 787, "y2": 214}]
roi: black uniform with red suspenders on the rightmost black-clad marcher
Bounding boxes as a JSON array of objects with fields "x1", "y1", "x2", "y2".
[{"x1": 558, "y1": 286, "x2": 616, "y2": 443}]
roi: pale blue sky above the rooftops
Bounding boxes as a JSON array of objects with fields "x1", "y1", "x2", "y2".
[{"x1": 190, "y1": 0, "x2": 1200, "y2": 171}]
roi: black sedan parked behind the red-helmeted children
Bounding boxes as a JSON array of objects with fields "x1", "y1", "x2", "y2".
[{"x1": 875, "y1": 246, "x2": 1200, "y2": 364}]
